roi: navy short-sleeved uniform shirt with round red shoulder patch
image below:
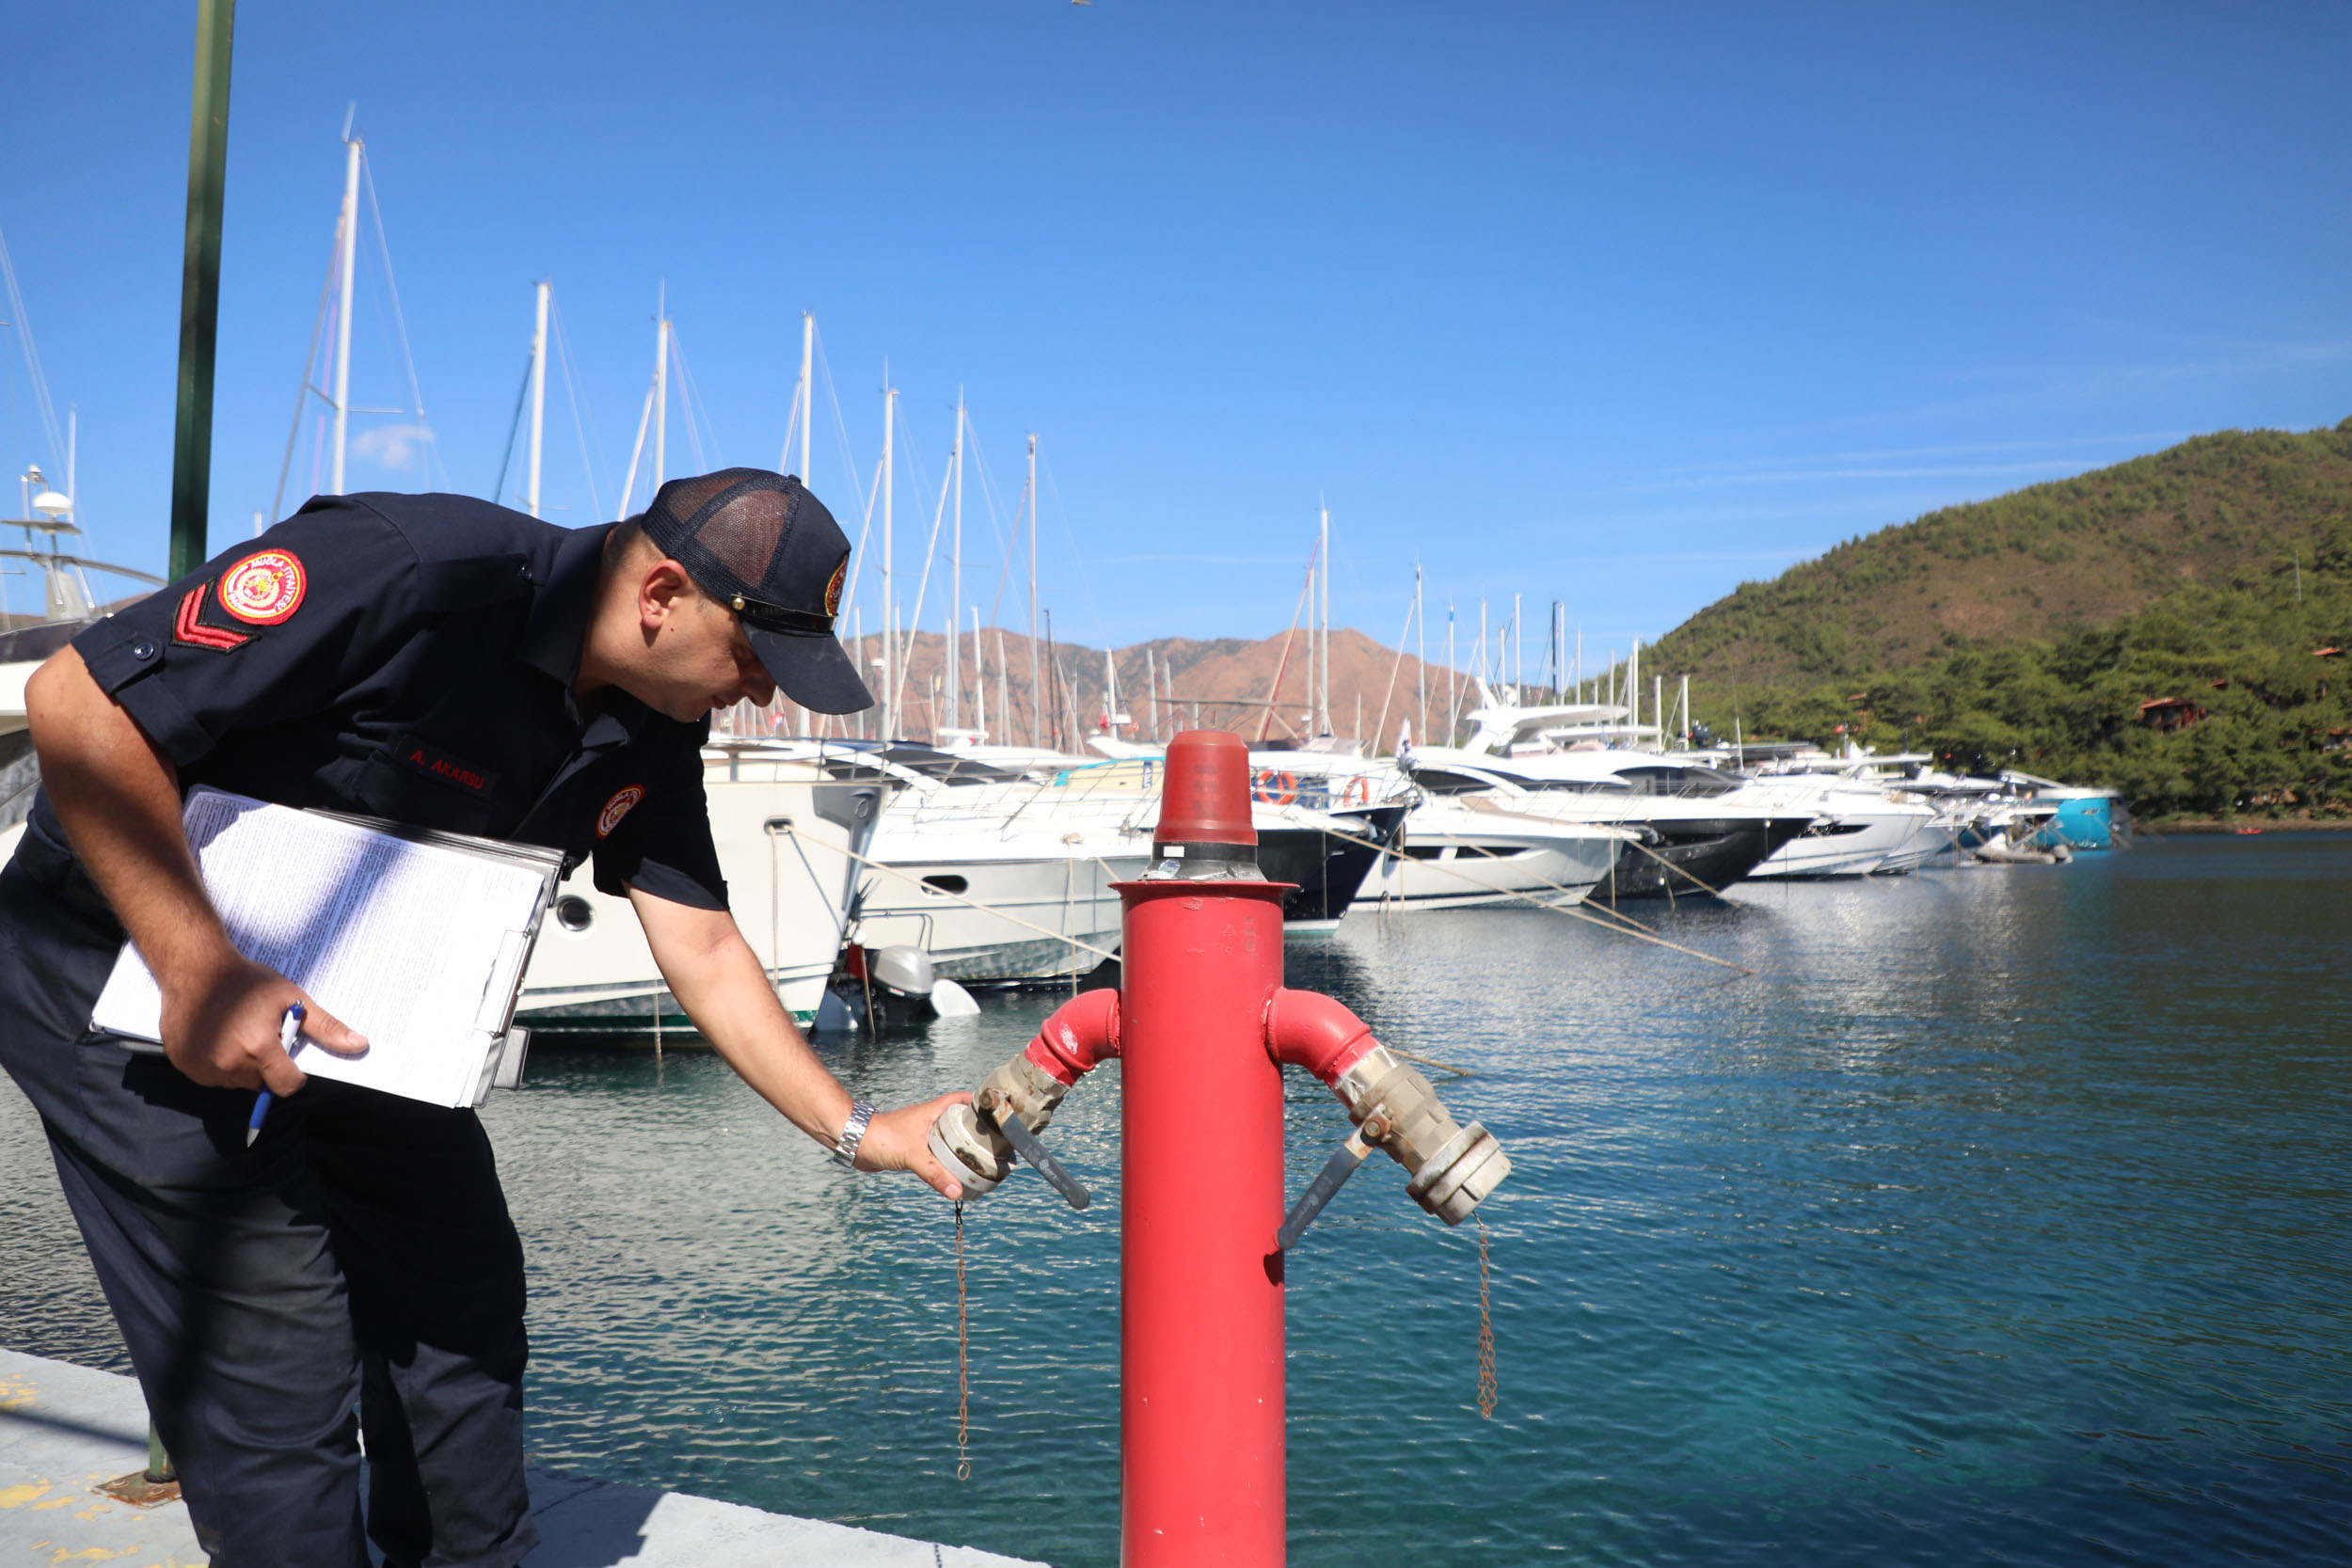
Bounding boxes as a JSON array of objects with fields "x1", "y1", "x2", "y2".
[{"x1": 33, "y1": 494, "x2": 727, "y2": 910}]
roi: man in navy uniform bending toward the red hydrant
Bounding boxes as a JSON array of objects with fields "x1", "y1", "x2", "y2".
[{"x1": 0, "y1": 467, "x2": 962, "y2": 1568}]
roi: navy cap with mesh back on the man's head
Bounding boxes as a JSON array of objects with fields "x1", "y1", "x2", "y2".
[{"x1": 643, "y1": 467, "x2": 875, "y2": 712}]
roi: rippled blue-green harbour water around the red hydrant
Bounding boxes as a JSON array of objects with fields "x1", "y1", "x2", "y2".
[{"x1": 0, "y1": 834, "x2": 2352, "y2": 1568}]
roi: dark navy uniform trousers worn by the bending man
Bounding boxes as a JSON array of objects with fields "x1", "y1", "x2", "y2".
[{"x1": 0, "y1": 814, "x2": 539, "y2": 1568}]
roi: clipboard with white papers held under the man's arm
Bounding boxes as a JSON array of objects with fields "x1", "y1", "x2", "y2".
[{"x1": 89, "y1": 785, "x2": 564, "y2": 1107}]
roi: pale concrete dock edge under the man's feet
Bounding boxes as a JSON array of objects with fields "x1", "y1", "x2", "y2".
[{"x1": 0, "y1": 1350, "x2": 1044, "y2": 1568}]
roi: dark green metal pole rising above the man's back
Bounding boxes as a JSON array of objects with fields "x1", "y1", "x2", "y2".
[{"x1": 165, "y1": 0, "x2": 238, "y2": 578}]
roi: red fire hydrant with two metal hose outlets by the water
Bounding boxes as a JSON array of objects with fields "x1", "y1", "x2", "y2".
[{"x1": 931, "y1": 729, "x2": 1510, "y2": 1568}]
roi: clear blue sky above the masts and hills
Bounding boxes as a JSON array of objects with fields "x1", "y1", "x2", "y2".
[{"x1": 0, "y1": 0, "x2": 2352, "y2": 656}]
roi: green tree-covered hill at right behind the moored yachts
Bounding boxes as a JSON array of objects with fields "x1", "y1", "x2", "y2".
[{"x1": 1651, "y1": 419, "x2": 2352, "y2": 814}]
